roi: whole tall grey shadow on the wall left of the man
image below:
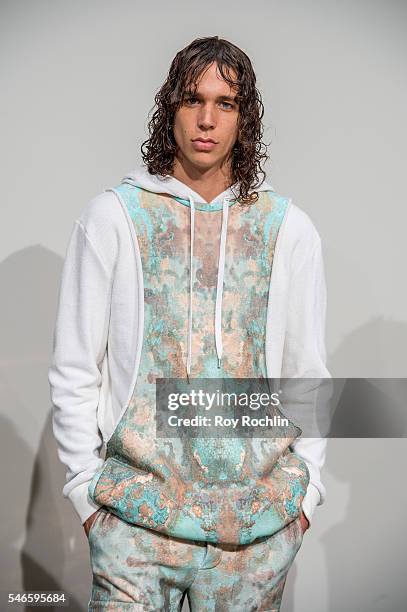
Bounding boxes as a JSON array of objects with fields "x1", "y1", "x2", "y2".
[{"x1": 0, "y1": 245, "x2": 91, "y2": 612}]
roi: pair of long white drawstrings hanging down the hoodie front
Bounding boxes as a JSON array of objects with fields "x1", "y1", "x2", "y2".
[{"x1": 187, "y1": 195, "x2": 230, "y2": 383}]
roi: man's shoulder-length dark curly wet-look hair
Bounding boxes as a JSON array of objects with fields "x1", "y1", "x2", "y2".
[{"x1": 141, "y1": 36, "x2": 268, "y2": 205}]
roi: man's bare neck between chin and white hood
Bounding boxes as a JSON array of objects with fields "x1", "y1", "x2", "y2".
[{"x1": 172, "y1": 158, "x2": 232, "y2": 202}]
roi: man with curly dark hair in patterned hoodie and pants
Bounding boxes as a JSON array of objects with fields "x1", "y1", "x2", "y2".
[{"x1": 49, "y1": 36, "x2": 329, "y2": 611}]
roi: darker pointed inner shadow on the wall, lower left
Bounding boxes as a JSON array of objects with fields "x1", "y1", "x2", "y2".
[{"x1": 21, "y1": 413, "x2": 91, "y2": 612}]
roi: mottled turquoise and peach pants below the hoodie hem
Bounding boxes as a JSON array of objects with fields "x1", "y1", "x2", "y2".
[{"x1": 88, "y1": 507, "x2": 303, "y2": 612}]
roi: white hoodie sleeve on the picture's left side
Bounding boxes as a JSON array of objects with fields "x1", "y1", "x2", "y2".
[{"x1": 48, "y1": 220, "x2": 112, "y2": 523}]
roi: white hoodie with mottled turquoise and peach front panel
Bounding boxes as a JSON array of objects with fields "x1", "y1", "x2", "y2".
[{"x1": 49, "y1": 166, "x2": 329, "y2": 544}]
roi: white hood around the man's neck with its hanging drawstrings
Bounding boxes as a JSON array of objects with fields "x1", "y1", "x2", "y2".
[{"x1": 122, "y1": 164, "x2": 274, "y2": 383}]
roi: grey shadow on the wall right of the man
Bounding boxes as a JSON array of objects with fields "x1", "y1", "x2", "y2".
[{"x1": 318, "y1": 317, "x2": 407, "y2": 612}]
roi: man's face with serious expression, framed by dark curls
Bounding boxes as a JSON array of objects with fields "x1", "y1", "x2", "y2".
[{"x1": 174, "y1": 63, "x2": 239, "y2": 170}]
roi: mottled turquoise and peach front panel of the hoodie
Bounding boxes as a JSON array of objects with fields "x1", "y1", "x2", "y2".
[{"x1": 89, "y1": 183, "x2": 309, "y2": 544}]
